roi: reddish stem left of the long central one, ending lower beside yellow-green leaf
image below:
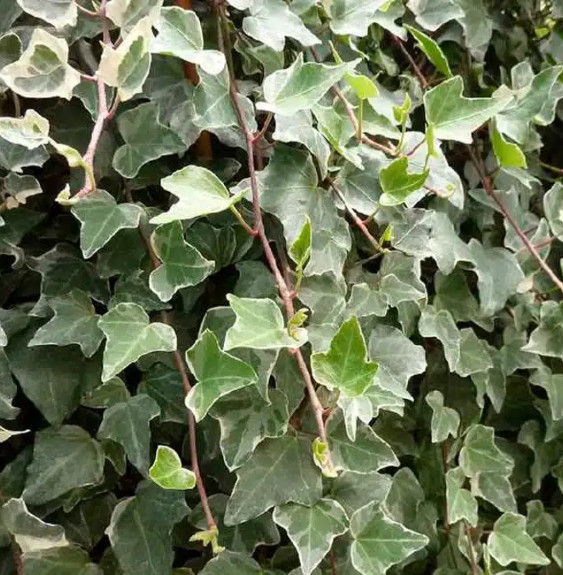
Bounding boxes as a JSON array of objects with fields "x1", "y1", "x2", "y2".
[{"x1": 124, "y1": 180, "x2": 217, "y2": 531}]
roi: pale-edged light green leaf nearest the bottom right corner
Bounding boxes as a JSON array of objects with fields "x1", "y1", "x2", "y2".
[{"x1": 487, "y1": 513, "x2": 550, "y2": 567}]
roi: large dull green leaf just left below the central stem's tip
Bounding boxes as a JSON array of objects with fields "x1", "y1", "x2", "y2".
[{"x1": 225, "y1": 435, "x2": 322, "y2": 525}]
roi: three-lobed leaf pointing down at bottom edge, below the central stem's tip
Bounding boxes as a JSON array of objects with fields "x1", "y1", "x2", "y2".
[{"x1": 274, "y1": 499, "x2": 348, "y2": 575}]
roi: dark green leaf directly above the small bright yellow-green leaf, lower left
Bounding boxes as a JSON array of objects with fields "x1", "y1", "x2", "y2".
[{"x1": 98, "y1": 394, "x2": 160, "y2": 476}]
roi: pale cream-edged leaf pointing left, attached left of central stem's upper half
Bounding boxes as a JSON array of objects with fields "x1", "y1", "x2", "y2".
[{"x1": 151, "y1": 164, "x2": 242, "y2": 224}]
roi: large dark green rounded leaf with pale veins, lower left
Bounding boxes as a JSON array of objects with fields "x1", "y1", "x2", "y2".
[{"x1": 22, "y1": 425, "x2": 104, "y2": 505}]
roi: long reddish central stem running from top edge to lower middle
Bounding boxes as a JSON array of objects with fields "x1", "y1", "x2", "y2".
[{"x1": 218, "y1": 3, "x2": 332, "y2": 468}]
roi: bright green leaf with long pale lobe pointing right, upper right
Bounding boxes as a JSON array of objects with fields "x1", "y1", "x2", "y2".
[{"x1": 424, "y1": 76, "x2": 510, "y2": 144}]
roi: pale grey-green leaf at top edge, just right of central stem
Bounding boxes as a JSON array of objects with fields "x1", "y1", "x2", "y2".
[{"x1": 242, "y1": 0, "x2": 320, "y2": 52}]
